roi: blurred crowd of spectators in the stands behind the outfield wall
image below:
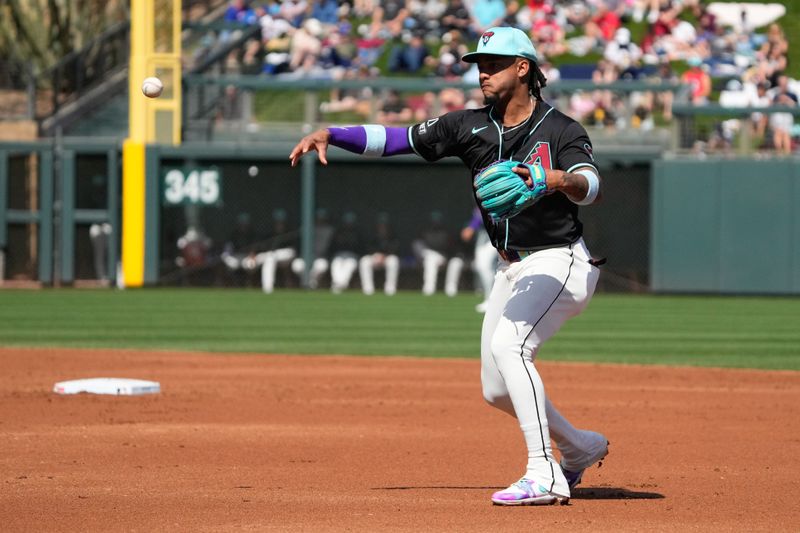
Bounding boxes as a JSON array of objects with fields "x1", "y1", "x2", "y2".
[{"x1": 205, "y1": 0, "x2": 800, "y2": 153}]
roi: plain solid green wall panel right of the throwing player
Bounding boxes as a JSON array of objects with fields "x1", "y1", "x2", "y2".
[{"x1": 650, "y1": 159, "x2": 800, "y2": 294}]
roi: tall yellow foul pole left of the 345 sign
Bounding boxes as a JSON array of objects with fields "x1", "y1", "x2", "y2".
[{"x1": 122, "y1": 0, "x2": 181, "y2": 287}]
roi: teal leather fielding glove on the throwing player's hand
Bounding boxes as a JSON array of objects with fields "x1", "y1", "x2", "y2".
[{"x1": 473, "y1": 161, "x2": 547, "y2": 220}]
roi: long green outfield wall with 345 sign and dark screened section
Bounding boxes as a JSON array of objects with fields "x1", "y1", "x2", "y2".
[{"x1": 0, "y1": 141, "x2": 800, "y2": 294}]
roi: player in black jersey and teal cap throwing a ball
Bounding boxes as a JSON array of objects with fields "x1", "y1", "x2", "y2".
[{"x1": 289, "y1": 27, "x2": 608, "y2": 505}]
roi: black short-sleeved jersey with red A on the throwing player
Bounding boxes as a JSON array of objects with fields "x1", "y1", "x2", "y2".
[{"x1": 409, "y1": 102, "x2": 594, "y2": 254}]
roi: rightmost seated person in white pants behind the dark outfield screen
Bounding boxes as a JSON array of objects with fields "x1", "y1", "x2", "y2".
[{"x1": 411, "y1": 211, "x2": 464, "y2": 296}]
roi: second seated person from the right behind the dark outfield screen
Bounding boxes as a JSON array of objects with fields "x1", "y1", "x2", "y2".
[{"x1": 358, "y1": 213, "x2": 400, "y2": 296}]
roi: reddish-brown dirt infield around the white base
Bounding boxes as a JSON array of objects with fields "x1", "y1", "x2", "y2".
[{"x1": 0, "y1": 349, "x2": 800, "y2": 533}]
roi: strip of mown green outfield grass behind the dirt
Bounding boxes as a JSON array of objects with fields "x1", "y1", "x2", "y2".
[{"x1": 0, "y1": 289, "x2": 800, "y2": 370}]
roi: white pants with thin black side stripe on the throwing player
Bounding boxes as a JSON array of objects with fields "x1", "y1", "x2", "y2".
[{"x1": 481, "y1": 239, "x2": 599, "y2": 497}]
